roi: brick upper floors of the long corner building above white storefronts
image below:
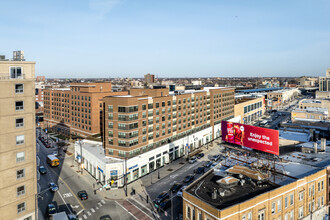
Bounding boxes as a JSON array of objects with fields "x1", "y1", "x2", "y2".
[{"x1": 103, "y1": 87, "x2": 234, "y2": 159}]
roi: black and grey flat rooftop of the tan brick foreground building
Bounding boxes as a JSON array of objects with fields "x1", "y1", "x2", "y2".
[{"x1": 186, "y1": 139, "x2": 330, "y2": 210}]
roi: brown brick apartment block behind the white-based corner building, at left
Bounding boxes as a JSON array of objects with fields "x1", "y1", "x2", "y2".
[{"x1": 44, "y1": 82, "x2": 127, "y2": 137}]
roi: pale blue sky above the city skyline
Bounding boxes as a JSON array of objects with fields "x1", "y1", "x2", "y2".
[{"x1": 0, "y1": 0, "x2": 330, "y2": 78}]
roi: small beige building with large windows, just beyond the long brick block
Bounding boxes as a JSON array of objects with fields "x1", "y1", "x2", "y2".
[{"x1": 234, "y1": 96, "x2": 265, "y2": 124}]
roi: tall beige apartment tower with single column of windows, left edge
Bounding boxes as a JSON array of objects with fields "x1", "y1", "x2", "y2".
[{"x1": 0, "y1": 54, "x2": 37, "y2": 220}]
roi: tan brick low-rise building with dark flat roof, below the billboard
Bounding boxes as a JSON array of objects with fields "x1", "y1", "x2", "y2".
[{"x1": 183, "y1": 146, "x2": 330, "y2": 220}]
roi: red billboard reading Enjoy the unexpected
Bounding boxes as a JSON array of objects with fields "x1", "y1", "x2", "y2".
[{"x1": 221, "y1": 121, "x2": 279, "y2": 155}]
